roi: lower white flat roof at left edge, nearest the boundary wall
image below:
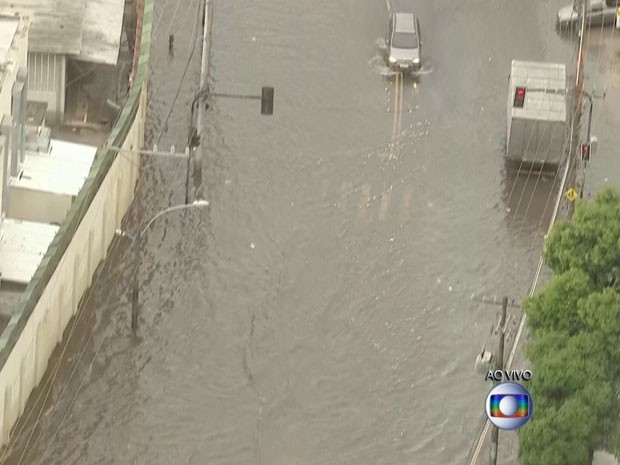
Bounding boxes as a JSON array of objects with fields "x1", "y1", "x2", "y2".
[{"x1": 0, "y1": 218, "x2": 59, "y2": 285}]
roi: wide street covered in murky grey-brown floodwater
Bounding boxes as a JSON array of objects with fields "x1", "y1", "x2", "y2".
[{"x1": 2, "y1": 0, "x2": 600, "y2": 465}]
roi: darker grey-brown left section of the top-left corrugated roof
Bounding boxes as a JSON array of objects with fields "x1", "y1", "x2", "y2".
[{"x1": 0, "y1": 0, "x2": 86, "y2": 55}]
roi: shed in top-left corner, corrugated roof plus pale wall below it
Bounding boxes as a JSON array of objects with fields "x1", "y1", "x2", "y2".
[{"x1": 0, "y1": 0, "x2": 124, "y2": 124}]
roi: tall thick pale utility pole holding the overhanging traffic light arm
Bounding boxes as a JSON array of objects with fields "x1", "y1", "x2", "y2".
[{"x1": 194, "y1": 0, "x2": 209, "y2": 198}]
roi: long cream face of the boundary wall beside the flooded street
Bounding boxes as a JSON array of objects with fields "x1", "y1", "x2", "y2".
[{"x1": 0, "y1": 86, "x2": 146, "y2": 445}]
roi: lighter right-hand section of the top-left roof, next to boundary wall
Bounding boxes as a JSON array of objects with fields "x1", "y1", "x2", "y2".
[{"x1": 77, "y1": 0, "x2": 125, "y2": 65}]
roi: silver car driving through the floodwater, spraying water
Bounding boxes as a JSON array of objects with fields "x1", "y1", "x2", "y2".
[{"x1": 388, "y1": 13, "x2": 422, "y2": 71}]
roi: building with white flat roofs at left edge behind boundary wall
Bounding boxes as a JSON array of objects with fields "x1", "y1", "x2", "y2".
[{"x1": 0, "y1": 10, "x2": 97, "y2": 319}]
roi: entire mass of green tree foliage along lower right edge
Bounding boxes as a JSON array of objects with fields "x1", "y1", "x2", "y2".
[{"x1": 519, "y1": 189, "x2": 620, "y2": 465}]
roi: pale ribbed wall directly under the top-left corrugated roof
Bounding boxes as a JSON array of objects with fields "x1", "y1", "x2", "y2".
[{"x1": 28, "y1": 52, "x2": 66, "y2": 123}]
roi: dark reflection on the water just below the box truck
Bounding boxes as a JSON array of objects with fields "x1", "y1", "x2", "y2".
[{"x1": 502, "y1": 159, "x2": 561, "y2": 239}]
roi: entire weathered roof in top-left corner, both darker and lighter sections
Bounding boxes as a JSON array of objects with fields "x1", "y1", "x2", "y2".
[{"x1": 0, "y1": 0, "x2": 124, "y2": 65}]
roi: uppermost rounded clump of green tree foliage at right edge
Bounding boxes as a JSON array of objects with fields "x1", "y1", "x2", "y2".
[{"x1": 544, "y1": 189, "x2": 620, "y2": 287}]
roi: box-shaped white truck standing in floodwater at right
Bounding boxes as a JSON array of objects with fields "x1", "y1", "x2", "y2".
[{"x1": 506, "y1": 60, "x2": 569, "y2": 166}]
